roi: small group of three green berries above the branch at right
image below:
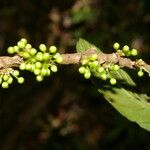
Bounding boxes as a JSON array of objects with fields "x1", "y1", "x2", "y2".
[{"x1": 113, "y1": 42, "x2": 138, "y2": 57}]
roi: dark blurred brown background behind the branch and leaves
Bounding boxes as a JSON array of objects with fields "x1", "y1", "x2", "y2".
[{"x1": 0, "y1": 0, "x2": 150, "y2": 150}]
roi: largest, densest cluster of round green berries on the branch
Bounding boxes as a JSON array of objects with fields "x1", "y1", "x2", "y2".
[{"x1": 8, "y1": 38, "x2": 63, "y2": 82}]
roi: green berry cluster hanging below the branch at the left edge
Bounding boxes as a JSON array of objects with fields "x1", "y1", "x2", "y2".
[{"x1": 0, "y1": 68, "x2": 24, "y2": 88}]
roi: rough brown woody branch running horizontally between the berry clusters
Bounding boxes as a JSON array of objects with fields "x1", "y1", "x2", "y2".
[{"x1": 0, "y1": 49, "x2": 150, "y2": 72}]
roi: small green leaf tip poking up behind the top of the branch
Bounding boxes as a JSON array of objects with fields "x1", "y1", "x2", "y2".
[{"x1": 76, "y1": 38, "x2": 100, "y2": 52}]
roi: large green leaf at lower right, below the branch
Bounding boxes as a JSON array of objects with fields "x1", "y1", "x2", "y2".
[{"x1": 98, "y1": 87, "x2": 150, "y2": 131}]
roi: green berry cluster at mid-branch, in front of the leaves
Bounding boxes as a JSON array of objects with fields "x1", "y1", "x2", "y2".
[{"x1": 79, "y1": 54, "x2": 120, "y2": 85}]
